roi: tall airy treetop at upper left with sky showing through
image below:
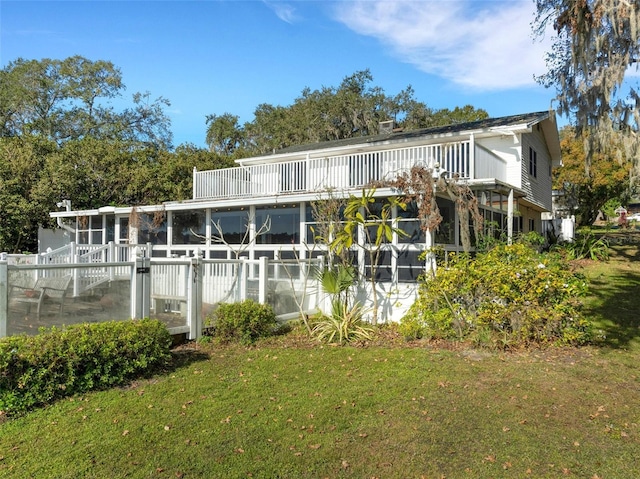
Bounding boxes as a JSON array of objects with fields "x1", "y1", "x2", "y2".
[{"x1": 0, "y1": 56, "x2": 171, "y2": 148}]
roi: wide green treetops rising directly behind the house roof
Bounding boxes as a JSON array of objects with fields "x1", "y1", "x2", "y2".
[{"x1": 212, "y1": 70, "x2": 488, "y2": 157}]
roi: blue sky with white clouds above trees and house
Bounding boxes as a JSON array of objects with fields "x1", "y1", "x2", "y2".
[{"x1": 0, "y1": 0, "x2": 554, "y2": 147}]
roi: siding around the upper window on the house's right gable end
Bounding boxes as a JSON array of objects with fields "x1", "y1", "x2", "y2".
[{"x1": 521, "y1": 125, "x2": 552, "y2": 211}]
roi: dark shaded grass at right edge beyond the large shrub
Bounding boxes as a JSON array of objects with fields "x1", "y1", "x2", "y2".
[{"x1": 585, "y1": 243, "x2": 640, "y2": 349}]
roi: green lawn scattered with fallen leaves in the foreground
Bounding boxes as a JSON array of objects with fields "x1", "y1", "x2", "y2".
[{"x1": 0, "y1": 238, "x2": 640, "y2": 479}]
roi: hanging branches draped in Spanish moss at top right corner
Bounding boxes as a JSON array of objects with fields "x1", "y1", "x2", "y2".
[{"x1": 534, "y1": 0, "x2": 640, "y2": 176}]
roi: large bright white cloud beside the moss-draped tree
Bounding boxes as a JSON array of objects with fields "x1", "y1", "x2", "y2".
[{"x1": 336, "y1": 0, "x2": 551, "y2": 90}]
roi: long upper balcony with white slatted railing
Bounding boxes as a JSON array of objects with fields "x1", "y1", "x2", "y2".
[{"x1": 193, "y1": 140, "x2": 506, "y2": 200}]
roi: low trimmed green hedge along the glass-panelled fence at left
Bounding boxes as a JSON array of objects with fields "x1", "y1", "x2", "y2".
[{"x1": 0, "y1": 319, "x2": 171, "y2": 415}]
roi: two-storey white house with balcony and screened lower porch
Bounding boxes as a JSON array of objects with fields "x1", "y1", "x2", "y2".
[{"x1": 44, "y1": 111, "x2": 561, "y2": 317}]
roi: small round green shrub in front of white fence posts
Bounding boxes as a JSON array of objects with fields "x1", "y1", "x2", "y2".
[{"x1": 207, "y1": 299, "x2": 277, "y2": 344}]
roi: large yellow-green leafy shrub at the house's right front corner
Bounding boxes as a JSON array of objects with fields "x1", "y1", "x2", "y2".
[{"x1": 401, "y1": 244, "x2": 591, "y2": 348}]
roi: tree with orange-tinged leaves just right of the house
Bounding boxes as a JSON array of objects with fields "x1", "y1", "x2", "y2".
[{"x1": 553, "y1": 127, "x2": 631, "y2": 225}]
